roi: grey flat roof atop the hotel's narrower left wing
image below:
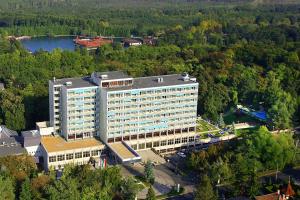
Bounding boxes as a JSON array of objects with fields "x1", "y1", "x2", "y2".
[{"x1": 51, "y1": 76, "x2": 97, "y2": 89}]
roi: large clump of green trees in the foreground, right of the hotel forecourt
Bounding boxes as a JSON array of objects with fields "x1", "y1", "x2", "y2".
[{"x1": 188, "y1": 127, "x2": 300, "y2": 200}]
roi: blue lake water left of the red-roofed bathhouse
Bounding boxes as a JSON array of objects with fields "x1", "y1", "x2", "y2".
[{"x1": 21, "y1": 37, "x2": 75, "y2": 52}]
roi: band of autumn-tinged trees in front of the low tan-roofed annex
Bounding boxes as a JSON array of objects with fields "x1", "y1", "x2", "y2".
[{"x1": 0, "y1": 156, "x2": 140, "y2": 200}]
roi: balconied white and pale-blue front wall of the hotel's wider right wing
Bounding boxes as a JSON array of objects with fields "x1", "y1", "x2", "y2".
[{"x1": 106, "y1": 83, "x2": 198, "y2": 142}]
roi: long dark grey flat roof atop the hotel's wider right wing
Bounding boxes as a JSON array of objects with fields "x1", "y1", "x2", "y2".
[{"x1": 105, "y1": 74, "x2": 197, "y2": 91}]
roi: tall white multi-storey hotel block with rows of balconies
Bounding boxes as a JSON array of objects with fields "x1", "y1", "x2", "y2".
[{"x1": 49, "y1": 72, "x2": 198, "y2": 152}]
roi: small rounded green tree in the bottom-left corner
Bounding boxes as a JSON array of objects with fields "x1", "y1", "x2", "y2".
[{"x1": 0, "y1": 174, "x2": 15, "y2": 200}]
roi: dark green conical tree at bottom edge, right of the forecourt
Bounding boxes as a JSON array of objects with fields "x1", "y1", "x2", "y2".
[{"x1": 195, "y1": 175, "x2": 217, "y2": 200}]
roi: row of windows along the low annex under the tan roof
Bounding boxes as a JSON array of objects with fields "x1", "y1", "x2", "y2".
[{"x1": 49, "y1": 150, "x2": 101, "y2": 162}]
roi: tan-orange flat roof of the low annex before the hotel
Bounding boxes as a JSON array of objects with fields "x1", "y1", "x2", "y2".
[{"x1": 41, "y1": 136, "x2": 104, "y2": 153}]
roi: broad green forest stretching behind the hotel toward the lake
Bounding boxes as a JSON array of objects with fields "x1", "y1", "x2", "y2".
[{"x1": 0, "y1": 1, "x2": 300, "y2": 130}]
